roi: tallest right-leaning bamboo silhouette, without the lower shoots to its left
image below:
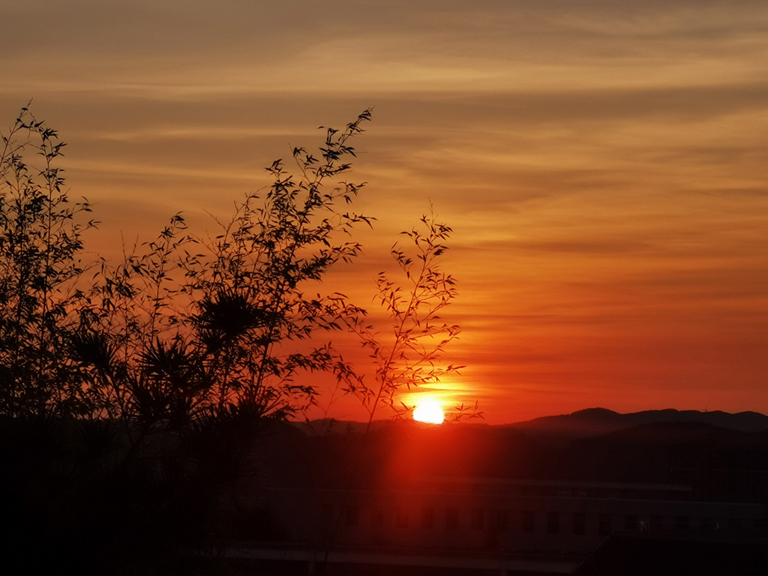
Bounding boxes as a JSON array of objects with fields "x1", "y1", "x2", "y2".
[{"x1": 180, "y1": 111, "x2": 371, "y2": 415}]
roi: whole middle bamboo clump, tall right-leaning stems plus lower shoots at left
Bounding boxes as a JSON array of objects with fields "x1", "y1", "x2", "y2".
[{"x1": 75, "y1": 111, "x2": 371, "y2": 428}]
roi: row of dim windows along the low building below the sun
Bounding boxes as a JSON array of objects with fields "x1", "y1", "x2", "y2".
[{"x1": 346, "y1": 504, "x2": 738, "y2": 535}]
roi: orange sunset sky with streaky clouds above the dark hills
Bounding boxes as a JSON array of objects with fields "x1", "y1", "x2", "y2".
[{"x1": 0, "y1": 0, "x2": 768, "y2": 424}]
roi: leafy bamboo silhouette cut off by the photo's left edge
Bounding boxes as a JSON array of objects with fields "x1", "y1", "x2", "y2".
[{"x1": 0, "y1": 107, "x2": 95, "y2": 416}]
